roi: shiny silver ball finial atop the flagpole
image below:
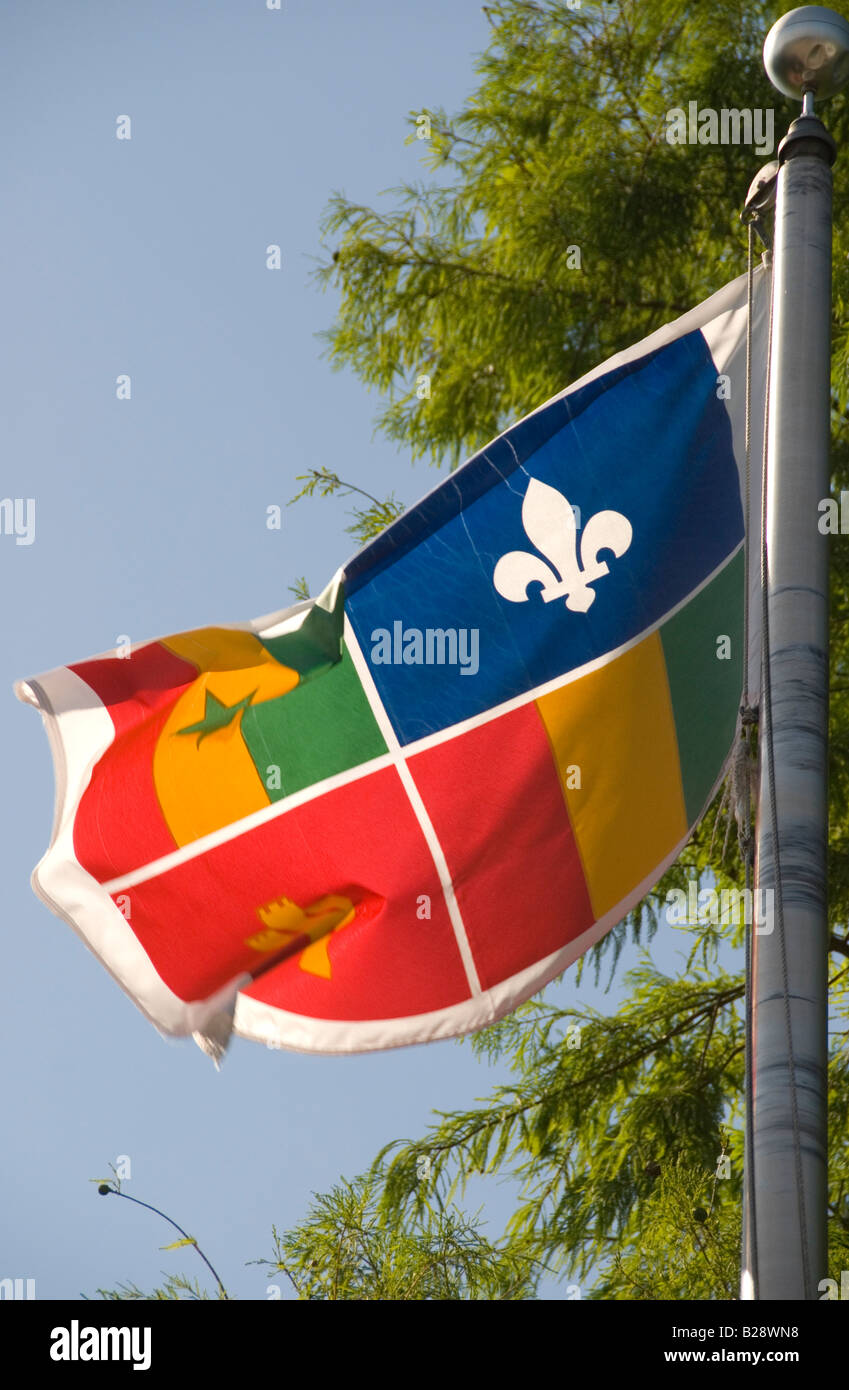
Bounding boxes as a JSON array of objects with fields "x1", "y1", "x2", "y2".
[{"x1": 763, "y1": 4, "x2": 849, "y2": 104}]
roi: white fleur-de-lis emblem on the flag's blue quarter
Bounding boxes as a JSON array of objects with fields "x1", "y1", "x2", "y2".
[{"x1": 492, "y1": 478, "x2": 634, "y2": 613}]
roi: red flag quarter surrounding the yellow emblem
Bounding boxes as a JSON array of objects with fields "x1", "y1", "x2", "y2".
[{"x1": 114, "y1": 767, "x2": 470, "y2": 1019}]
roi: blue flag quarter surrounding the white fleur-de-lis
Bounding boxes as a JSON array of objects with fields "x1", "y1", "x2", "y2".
[{"x1": 346, "y1": 331, "x2": 743, "y2": 744}]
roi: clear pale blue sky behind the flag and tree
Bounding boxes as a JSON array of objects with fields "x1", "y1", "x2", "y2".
[{"x1": 0, "y1": 0, "x2": 728, "y2": 1300}]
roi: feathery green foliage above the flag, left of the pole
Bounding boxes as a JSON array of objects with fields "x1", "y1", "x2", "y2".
[{"x1": 317, "y1": 0, "x2": 805, "y2": 463}]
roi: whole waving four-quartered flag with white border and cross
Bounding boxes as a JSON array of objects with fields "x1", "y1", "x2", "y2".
[{"x1": 17, "y1": 271, "x2": 766, "y2": 1056}]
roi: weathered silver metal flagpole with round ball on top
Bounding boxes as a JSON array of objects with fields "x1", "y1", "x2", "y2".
[{"x1": 741, "y1": 6, "x2": 849, "y2": 1300}]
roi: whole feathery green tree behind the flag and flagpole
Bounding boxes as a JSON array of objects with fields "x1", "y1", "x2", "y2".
[{"x1": 97, "y1": 0, "x2": 849, "y2": 1298}]
